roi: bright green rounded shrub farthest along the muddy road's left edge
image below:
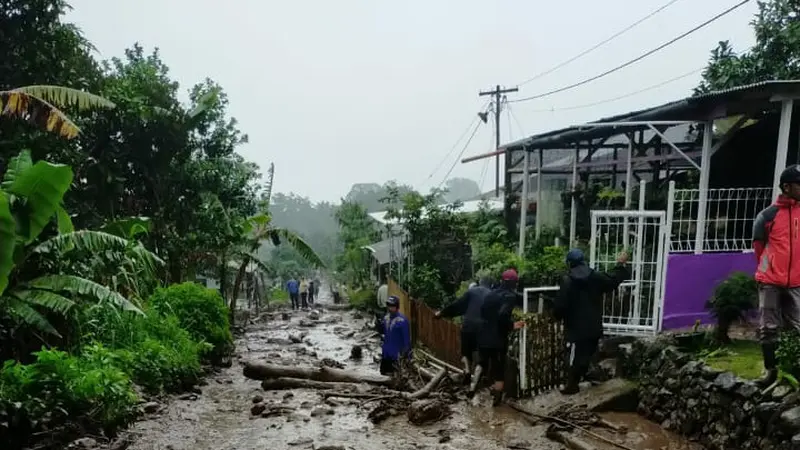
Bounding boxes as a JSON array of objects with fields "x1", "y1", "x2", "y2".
[{"x1": 148, "y1": 282, "x2": 233, "y2": 362}]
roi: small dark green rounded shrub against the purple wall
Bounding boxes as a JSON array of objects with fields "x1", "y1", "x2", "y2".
[{"x1": 706, "y1": 272, "x2": 758, "y2": 344}]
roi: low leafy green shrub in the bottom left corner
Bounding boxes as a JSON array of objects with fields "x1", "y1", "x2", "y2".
[{"x1": 0, "y1": 346, "x2": 138, "y2": 431}]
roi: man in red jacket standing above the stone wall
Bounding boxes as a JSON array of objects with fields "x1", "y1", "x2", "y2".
[{"x1": 753, "y1": 165, "x2": 800, "y2": 386}]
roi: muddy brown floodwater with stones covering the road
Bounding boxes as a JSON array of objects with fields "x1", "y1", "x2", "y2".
[{"x1": 122, "y1": 294, "x2": 701, "y2": 450}]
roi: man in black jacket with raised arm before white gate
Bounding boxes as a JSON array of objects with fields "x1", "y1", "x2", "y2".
[{"x1": 554, "y1": 249, "x2": 630, "y2": 395}]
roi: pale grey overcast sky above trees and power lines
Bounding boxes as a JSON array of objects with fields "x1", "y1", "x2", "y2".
[{"x1": 68, "y1": 0, "x2": 757, "y2": 201}]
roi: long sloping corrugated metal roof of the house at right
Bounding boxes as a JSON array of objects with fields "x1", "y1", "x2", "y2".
[{"x1": 500, "y1": 80, "x2": 800, "y2": 150}]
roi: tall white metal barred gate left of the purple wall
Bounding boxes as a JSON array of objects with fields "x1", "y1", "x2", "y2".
[{"x1": 589, "y1": 211, "x2": 667, "y2": 336}]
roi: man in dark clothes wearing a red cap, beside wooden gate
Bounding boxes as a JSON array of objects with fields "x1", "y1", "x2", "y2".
[{"x1": 476, "y1": 269, "x2": 525, "y2": 406}]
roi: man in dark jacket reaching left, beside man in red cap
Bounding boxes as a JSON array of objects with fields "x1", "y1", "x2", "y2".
[{"x1": 436, "y1": 278, "x2": 492, "y2": 385}]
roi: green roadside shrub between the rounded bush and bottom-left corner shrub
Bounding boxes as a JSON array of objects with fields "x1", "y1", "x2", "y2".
[{"x1": 80, "y1": 307, "x2": 206, "y2": 393}]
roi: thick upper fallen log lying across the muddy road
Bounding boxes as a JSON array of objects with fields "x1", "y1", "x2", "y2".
[{"x1": 242, "y1": 362, "x2": 392, "y2": 386}]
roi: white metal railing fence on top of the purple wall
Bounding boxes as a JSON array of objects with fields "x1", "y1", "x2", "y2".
[{"x1": 667, "y1": 182, "x2": 772, "y2": 253}]
